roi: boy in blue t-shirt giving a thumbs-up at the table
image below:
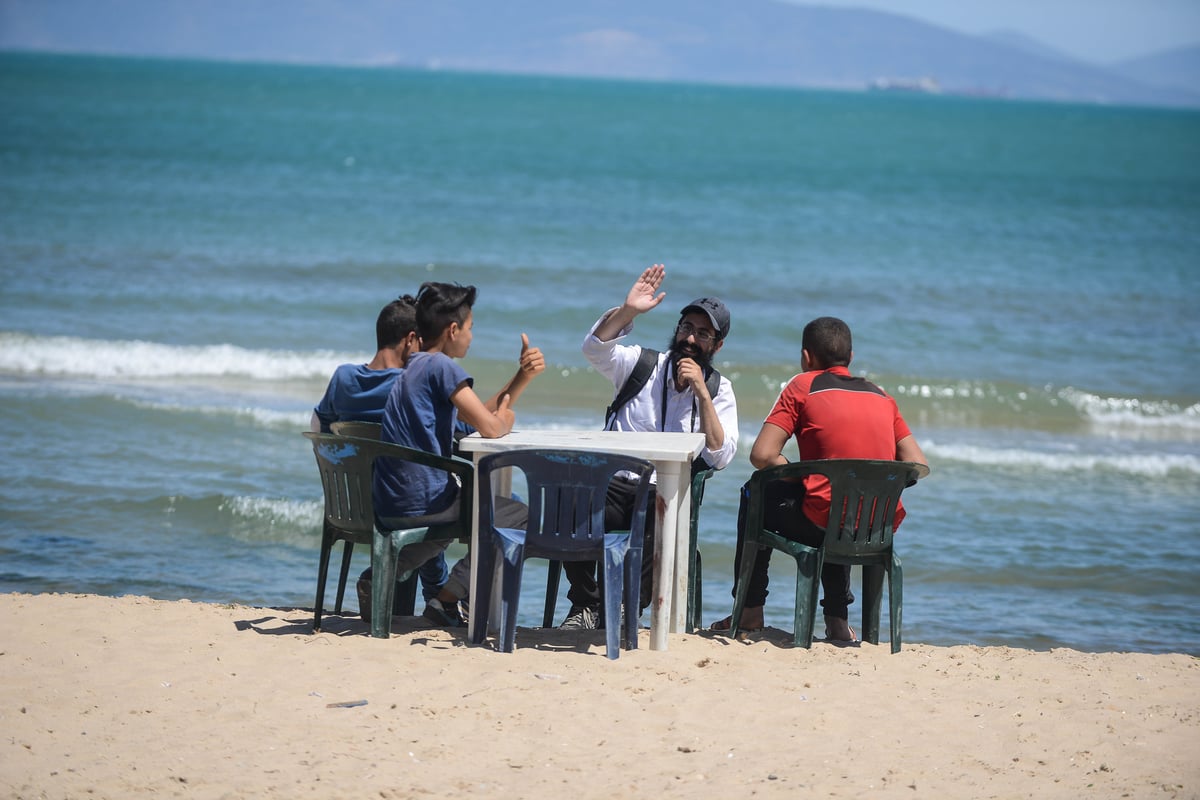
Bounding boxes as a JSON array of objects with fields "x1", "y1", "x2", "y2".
[{"x1": 374, "y1": 282, "x2": 546, "y2": 625}]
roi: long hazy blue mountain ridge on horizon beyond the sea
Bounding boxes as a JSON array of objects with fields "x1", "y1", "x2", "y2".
[{"x1": 0, "y1": 0, "x2": 1200, "y2": 106}]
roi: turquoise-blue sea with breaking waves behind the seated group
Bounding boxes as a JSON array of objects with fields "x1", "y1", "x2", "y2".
[{"x1": 0, "y1": 53, "x2": 1200, "y2": 655}]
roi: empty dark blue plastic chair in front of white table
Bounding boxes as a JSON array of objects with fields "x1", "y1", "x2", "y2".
[{"x1": 470, "y1": 449, "x2": 654, "y2": 658}]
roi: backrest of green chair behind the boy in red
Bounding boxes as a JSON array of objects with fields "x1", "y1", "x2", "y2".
[{"x1": 750, "y1": 458, "x2": 929, "y2": 564}]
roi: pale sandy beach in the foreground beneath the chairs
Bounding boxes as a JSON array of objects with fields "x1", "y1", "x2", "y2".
[{"x1": 0, "y1": 594, "x2": 1200, "y2": 798}]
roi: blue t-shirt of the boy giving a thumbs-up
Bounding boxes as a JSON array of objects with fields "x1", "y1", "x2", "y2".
[{"x1": 374, "y1": 353, "x2": 474, "y2": 517}]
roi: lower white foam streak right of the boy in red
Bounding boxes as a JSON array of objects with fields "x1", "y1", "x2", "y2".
[{"x1": 923, "y1": 443, "x2": 1200, "y2": 477}]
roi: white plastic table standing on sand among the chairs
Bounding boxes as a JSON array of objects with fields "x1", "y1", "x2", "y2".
[{"x1": 458, "y1": 429, "x2": 704, "y2": 650}]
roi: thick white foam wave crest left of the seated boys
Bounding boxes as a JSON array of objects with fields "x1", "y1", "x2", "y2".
[{"x1": 0, "y1": 331, "x2": 350, "y2": 380}]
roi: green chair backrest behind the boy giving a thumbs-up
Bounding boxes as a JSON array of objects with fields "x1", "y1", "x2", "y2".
[{"x1": 304, "y1": 431, "x2": 475, "y2": 537}]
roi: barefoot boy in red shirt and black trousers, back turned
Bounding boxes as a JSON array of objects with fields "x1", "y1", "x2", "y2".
[{"x1": 713, "y1": 317, "x2": 925, "y2": 642}]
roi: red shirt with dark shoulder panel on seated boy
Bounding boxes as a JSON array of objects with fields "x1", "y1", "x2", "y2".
[{"x1": 767, "y1": 367, "x2": 911, "y2": 528}]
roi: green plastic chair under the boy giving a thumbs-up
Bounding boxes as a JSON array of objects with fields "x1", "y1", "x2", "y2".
[{"x1": 304, "y1": 431, "x2": 475, "y2": 639}]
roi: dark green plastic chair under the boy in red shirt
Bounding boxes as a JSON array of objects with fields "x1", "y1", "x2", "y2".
[{"x1": 730, "y1": 458, "x2": 929, "y2": 652}]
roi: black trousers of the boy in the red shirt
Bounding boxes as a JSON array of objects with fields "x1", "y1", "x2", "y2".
[{"x1": 733, "y1": 481, "x2": 854, "y2": 619}]
